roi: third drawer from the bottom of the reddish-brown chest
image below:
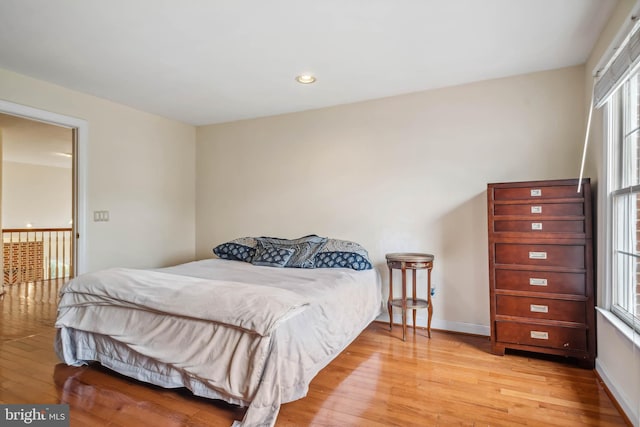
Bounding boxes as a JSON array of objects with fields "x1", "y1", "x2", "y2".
[{"x1": 495, "y1": 269, "x2": 586, "y2": 295}]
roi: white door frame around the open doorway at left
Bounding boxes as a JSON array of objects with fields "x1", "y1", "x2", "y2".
[{"x1": 0, "y1": 99, "x2": 89, "y2": 276}]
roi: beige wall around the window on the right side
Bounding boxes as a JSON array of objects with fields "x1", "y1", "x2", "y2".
[{"x1": 585, "y1": 0, "x2": 640, "y2": 425}]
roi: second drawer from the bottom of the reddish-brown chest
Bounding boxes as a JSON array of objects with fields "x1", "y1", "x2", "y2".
[{"x1": 496, "y1": 295, "x2": 586, "y2": 323}]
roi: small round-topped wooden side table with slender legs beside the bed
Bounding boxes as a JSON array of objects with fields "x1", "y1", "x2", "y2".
[{"x1": 386, "y1": 253, "x2": 433, "y2": 341}]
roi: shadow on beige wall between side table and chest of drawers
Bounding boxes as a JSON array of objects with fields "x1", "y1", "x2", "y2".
[{"x1": 434, "y1": 192, "x2": 489, "y2": 332}]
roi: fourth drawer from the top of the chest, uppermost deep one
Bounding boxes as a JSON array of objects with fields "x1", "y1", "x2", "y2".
[{"x1": 495, "y1": 243, "x2": 585, "y2": 268}]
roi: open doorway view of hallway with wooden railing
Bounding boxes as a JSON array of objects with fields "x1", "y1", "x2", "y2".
[{"x1": 0, "y1": 114, "x2": 74, "y2": 285}]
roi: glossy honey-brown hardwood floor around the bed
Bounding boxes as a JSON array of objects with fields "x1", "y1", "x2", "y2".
[{"x1": 0, "y1": 282, "x2": 625, "y2": 427}]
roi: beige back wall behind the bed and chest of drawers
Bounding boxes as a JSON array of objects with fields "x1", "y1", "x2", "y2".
[{"x1": 196, "y1": 67, "x2": 584, "y2": 334}]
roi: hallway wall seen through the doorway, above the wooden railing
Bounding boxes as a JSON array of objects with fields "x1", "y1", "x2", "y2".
[{"x1": 0, "y1": 162, "x2": 72, "y2": 228}]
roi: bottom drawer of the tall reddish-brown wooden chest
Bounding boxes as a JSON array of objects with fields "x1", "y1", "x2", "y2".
[{"x1": 496, "y1": 321, "x2": 587, "y2": 351}]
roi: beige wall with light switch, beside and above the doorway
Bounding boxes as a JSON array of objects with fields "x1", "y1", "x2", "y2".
[{"x1": 0, "y1": 70, "x2": 195, "y2": 271}]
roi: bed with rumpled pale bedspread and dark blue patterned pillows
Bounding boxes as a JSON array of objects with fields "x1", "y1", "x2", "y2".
[{"x1": 55, "y1": 236, "x2": 382, "y2": 427}]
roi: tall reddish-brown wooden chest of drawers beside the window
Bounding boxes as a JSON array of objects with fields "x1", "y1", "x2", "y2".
[{"x1": 487, "y1": 179, "x2": 596, "y2": 367}]
